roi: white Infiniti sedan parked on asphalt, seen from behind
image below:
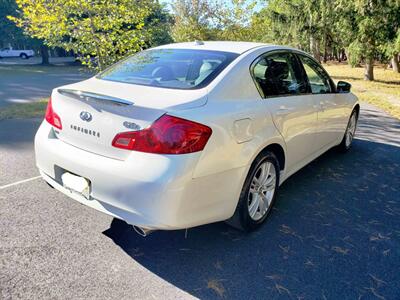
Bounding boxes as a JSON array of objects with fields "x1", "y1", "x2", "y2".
[{"x1": 35, "y1": 42, "x2": 360, "y2": 235}]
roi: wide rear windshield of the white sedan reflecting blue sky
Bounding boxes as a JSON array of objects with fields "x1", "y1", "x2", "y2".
[{"x1": 97, "y1": 49, "x2": 238, "y2": 89}]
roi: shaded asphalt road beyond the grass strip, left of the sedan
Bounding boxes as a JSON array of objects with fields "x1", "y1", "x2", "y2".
[{"x1": 0, "y1": 62, "x2": 91, "y2": 109}]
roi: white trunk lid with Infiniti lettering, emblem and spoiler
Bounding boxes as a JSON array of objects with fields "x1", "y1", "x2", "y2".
[{"x1": 52, "y1": 78, "x2": 206, "y2": 160}]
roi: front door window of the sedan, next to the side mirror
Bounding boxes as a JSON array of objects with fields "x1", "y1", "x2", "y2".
[{"x1": 300, "y1": 55, "x2": 332, "y2": 94}]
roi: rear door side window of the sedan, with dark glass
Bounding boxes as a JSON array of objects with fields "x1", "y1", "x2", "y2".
[{"x1": 252, "y1": 53, "x2": 305, "y2": 97}]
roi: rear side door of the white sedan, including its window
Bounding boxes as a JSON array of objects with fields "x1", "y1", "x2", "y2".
[{"x1": 252, "y1": 51, "x2": 317, "y2": 173}]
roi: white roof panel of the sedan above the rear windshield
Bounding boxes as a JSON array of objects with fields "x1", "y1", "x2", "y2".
[{"x1": 153, "y1": 41, "x2": 271, "y2": 54}]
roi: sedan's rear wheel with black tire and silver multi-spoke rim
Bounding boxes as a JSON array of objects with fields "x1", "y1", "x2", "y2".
[{"x1": 226, "y1": 151, "x2": 280, "y2": 232}]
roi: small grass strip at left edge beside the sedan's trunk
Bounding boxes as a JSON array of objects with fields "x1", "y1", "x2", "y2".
[{"x1": 0, "y1": 99, "x2": 47, "y2": 120}]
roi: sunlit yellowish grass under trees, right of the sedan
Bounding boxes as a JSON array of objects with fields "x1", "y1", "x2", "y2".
[{"x1": 324, "y1": 63, "x2": 400, "y2": 119}]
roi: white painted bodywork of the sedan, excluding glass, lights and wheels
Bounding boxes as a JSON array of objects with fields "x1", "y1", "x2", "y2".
[{"x1": 35, "y1": 42, "x2": 358, "y2": 230}]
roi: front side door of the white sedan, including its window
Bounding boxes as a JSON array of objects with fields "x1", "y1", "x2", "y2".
[{"x1": 297, "y1": 54, "x2": 347, "y2": 149}]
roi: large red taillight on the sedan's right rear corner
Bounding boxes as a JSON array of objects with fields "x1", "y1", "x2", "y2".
[{"x1": 112, "y1": 115, "x2": 212, "y2": 154}]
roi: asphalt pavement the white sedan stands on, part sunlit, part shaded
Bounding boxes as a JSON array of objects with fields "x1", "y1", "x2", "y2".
[{"x1": 0, "y1": 105, "x2": 400, "y2": 299}]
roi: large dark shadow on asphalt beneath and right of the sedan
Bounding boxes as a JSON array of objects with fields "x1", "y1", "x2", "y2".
[{"x1": 104, "y1": 140, "x2": 400, "y2": 299}]
